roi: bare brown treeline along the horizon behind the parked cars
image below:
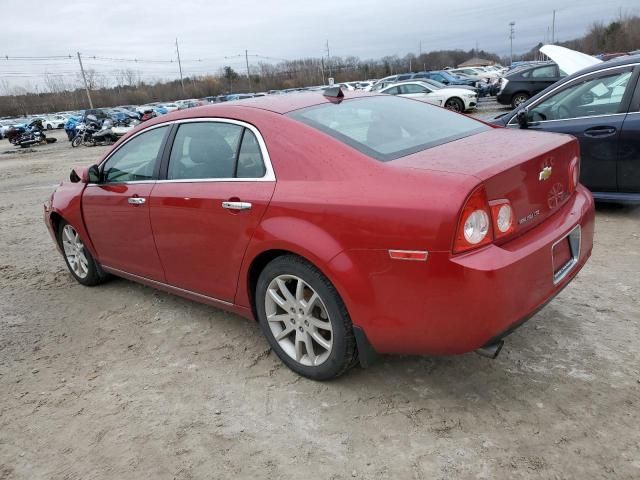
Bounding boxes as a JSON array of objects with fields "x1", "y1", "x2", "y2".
[{"x1": 0, "y1": 16, "x2": 640, "y2": 117}]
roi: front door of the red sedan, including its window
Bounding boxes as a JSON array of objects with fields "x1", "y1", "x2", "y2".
[{"x1": 82, "y1": 126, "x2": 169, "y2": 282}]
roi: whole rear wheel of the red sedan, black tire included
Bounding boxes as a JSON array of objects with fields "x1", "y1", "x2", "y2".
[{"x1": 254, "y1": 255, "x2": 357, "y2": 380}]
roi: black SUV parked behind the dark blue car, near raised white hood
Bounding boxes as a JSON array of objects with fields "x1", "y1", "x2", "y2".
[{"x1": 496, "y1": 63, "x2": 564, "y2": 108}]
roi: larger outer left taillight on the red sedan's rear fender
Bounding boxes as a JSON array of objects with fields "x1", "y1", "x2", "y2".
[{"x1": 453, "y1": 186, "x2": 493, "y2": 253}]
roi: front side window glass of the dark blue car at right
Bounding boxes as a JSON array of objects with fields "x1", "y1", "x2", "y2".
[{"x1": 529, "y1": 70, "x2": 631, "y2": 122}]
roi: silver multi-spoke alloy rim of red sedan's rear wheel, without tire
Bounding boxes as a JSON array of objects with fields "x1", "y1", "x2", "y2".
[{"x1": 264, "y1": 275, "x2": 333, "y2": 366}]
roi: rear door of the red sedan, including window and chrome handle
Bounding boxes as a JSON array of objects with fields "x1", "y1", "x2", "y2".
[{"x1": 150, "y1": 119, "x2": 275, "y2": 302}]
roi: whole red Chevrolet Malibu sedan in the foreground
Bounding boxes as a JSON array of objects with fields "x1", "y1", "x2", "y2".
[{"x1": 45, "y1": 92, "x2": 594, "y2": 379}]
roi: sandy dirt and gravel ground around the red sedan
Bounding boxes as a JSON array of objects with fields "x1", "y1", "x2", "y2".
[{"x1": 0, "y1": 118, "x2": 640, "y2": 480}]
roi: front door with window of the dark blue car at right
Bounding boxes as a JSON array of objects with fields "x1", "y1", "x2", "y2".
[{"x1": 508, "y1": 67, "x2": 632, "y2": 192}]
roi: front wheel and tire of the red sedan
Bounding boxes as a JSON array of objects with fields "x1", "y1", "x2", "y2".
[{"x1": 58, "y1": 220, "x2": 107, "y2": 287}]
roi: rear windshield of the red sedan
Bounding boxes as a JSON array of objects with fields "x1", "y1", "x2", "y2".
[{"x1": 288, "y1": 96, "x2": 491, "y2": 162}]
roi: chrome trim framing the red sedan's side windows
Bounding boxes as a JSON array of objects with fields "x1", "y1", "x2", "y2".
[{"x1": 87, "y1": 117, "x2": 276, "y2": 187}]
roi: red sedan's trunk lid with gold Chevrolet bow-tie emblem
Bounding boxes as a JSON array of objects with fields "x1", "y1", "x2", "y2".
[{"x1": 388, "y1": 129, "x2": 579, "y2": 233}]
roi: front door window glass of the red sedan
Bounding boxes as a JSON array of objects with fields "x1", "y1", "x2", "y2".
[{"x1": 102, "y1": 126, "x2": 169, "y2": 183}]
